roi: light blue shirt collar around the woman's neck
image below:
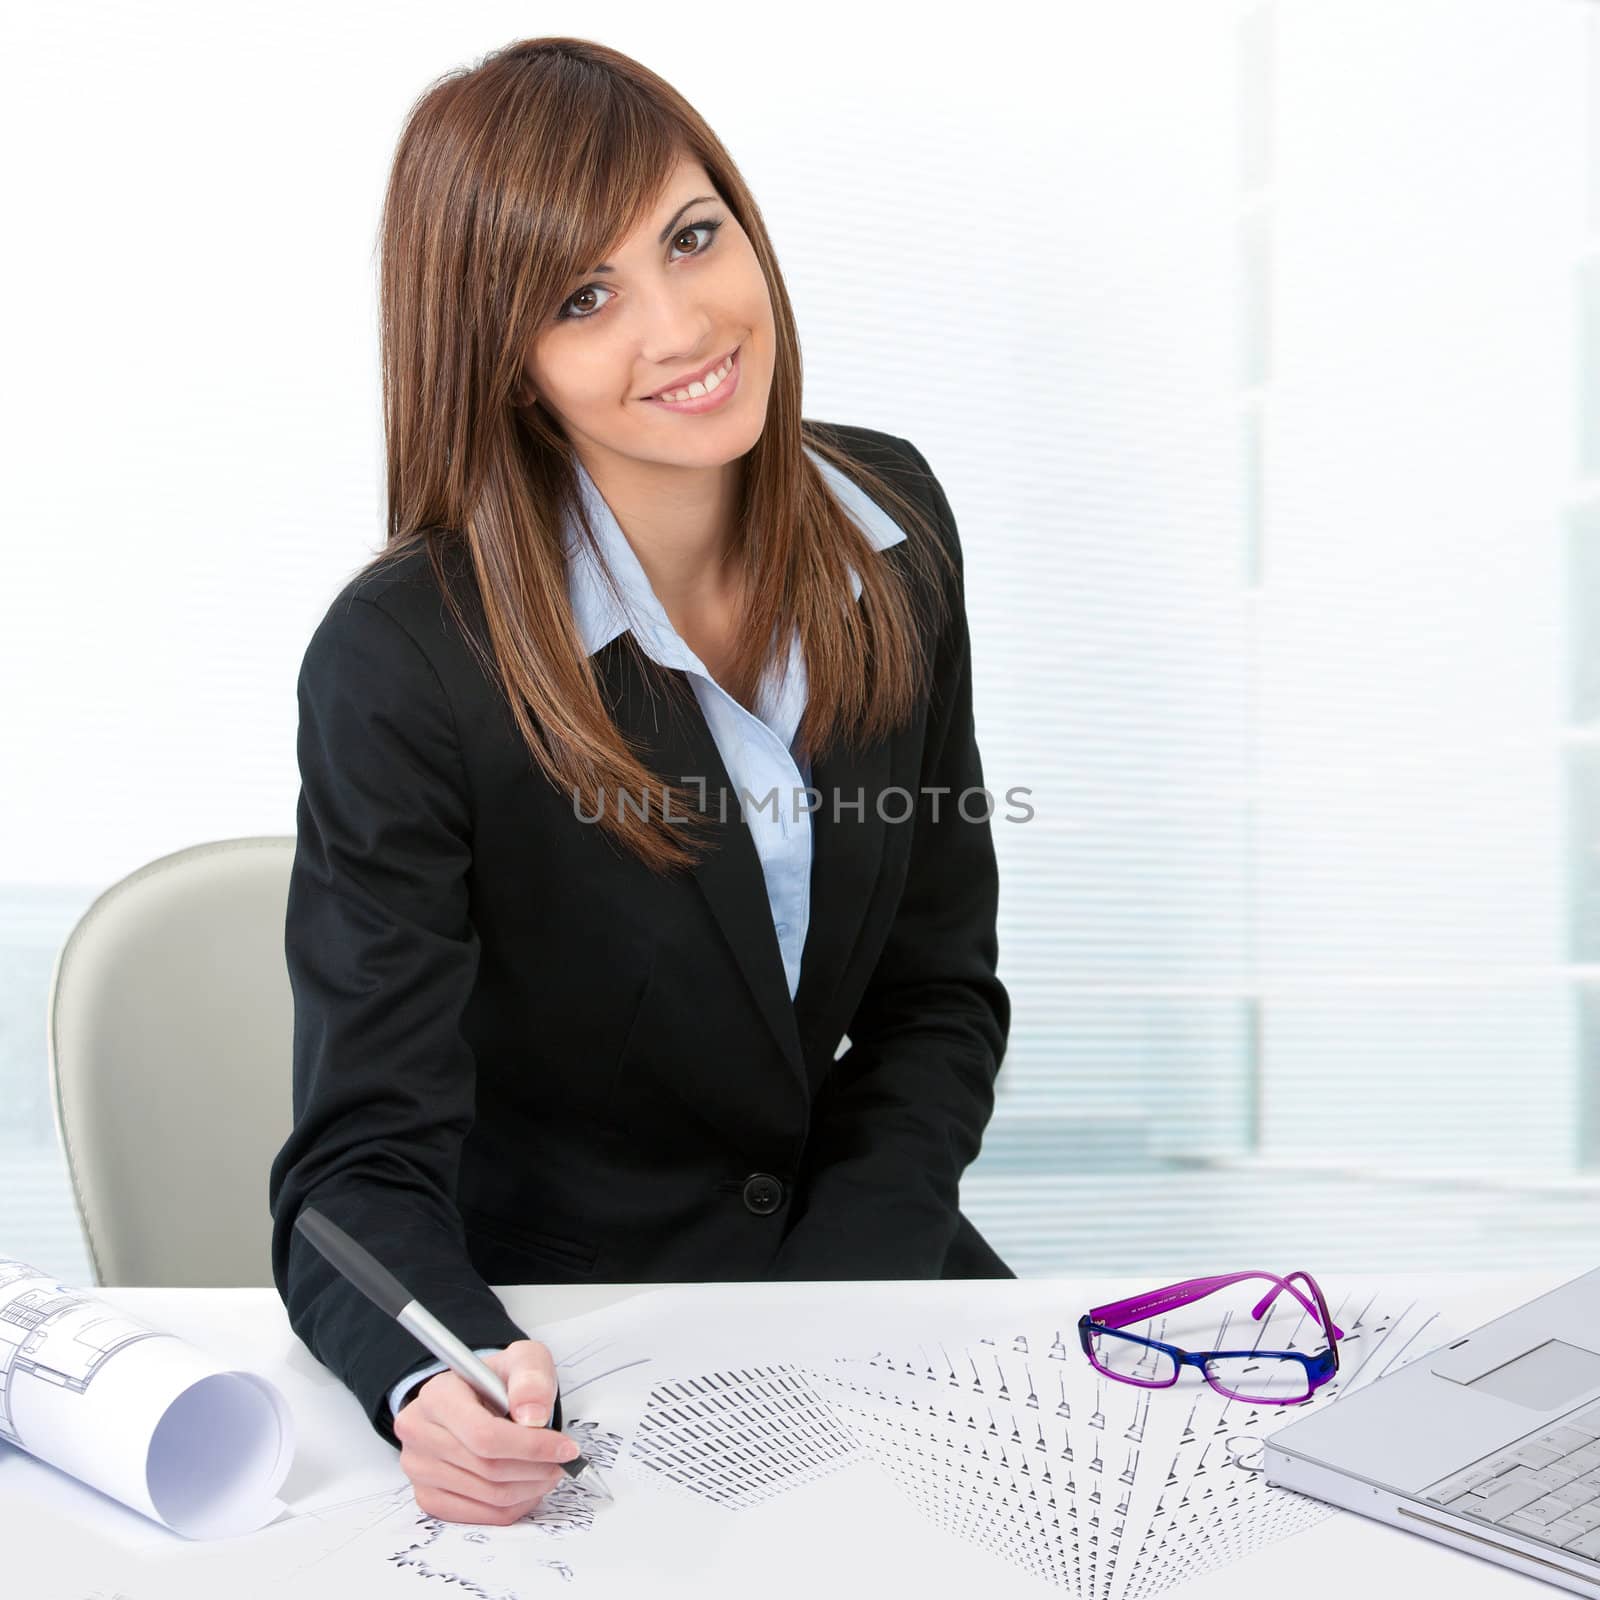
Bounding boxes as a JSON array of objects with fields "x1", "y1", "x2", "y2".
[{"x1": 563, "y1": 445, "x2": 906, "y2": 656}]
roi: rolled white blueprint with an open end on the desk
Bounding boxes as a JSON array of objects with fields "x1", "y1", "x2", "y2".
[{"x1": 0, "y1": 1256, "x2": 294, "y2": 1539}]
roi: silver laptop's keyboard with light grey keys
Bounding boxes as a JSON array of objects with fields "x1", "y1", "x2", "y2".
[{"x1": 1421, "y1": 1405, "x2": 1600, "y2": 1562}]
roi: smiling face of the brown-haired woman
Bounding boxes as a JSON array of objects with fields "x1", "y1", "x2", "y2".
[{"x1": 523, "y1": 158, "x2": 774, "y2": 467}]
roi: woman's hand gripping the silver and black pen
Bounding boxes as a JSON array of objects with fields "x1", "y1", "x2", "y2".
[{"x1": 395, "y1": 1339, "x2": 578, "y2": 1528}]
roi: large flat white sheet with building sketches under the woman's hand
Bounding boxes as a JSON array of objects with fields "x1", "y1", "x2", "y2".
[{"x1": 50, "y1": 1280, "x2": 1453, "y2": 1600}]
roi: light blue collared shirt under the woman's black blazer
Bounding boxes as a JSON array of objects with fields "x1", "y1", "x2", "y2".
[{"x1": 389, "y1": 445, "x2": 906, "y2": 1414}]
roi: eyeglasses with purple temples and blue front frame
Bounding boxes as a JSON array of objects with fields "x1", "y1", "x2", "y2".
[{"x1": 1078, "y1": 1272, "x2": 1344, "y2": 1405}]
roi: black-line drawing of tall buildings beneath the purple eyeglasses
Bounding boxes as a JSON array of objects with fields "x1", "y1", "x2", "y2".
[{"x1": 787, "y1": 1296, "x2": 1435, "y2": 1600}]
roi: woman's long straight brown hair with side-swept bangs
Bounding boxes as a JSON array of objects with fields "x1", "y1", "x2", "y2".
[{"x1": 368, "y1": 38, "x2": 954, "y2": 870}]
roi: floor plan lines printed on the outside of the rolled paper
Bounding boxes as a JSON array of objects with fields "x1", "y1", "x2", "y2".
[{"x1": 0, "y1": 1258, "x2": 171, "y2": 1448}]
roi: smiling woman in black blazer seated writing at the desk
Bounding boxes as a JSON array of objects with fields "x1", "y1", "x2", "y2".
[{"x1": 270, "y1": 38, "x2": 1014, "y2": 1522}]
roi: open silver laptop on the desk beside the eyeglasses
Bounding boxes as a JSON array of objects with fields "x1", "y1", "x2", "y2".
[{"x1": 1262, "y1": 1267, "x2": 1600, "y2": 1597}]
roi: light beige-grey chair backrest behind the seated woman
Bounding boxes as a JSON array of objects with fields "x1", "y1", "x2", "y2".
[{"x1": 46, "y1": 837, "x2": 294, "y2": 1286}]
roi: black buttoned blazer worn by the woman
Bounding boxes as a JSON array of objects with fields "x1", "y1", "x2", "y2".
[{"x1": 269, "y1": 424, "x2": 1014, "y2": 1442}]
